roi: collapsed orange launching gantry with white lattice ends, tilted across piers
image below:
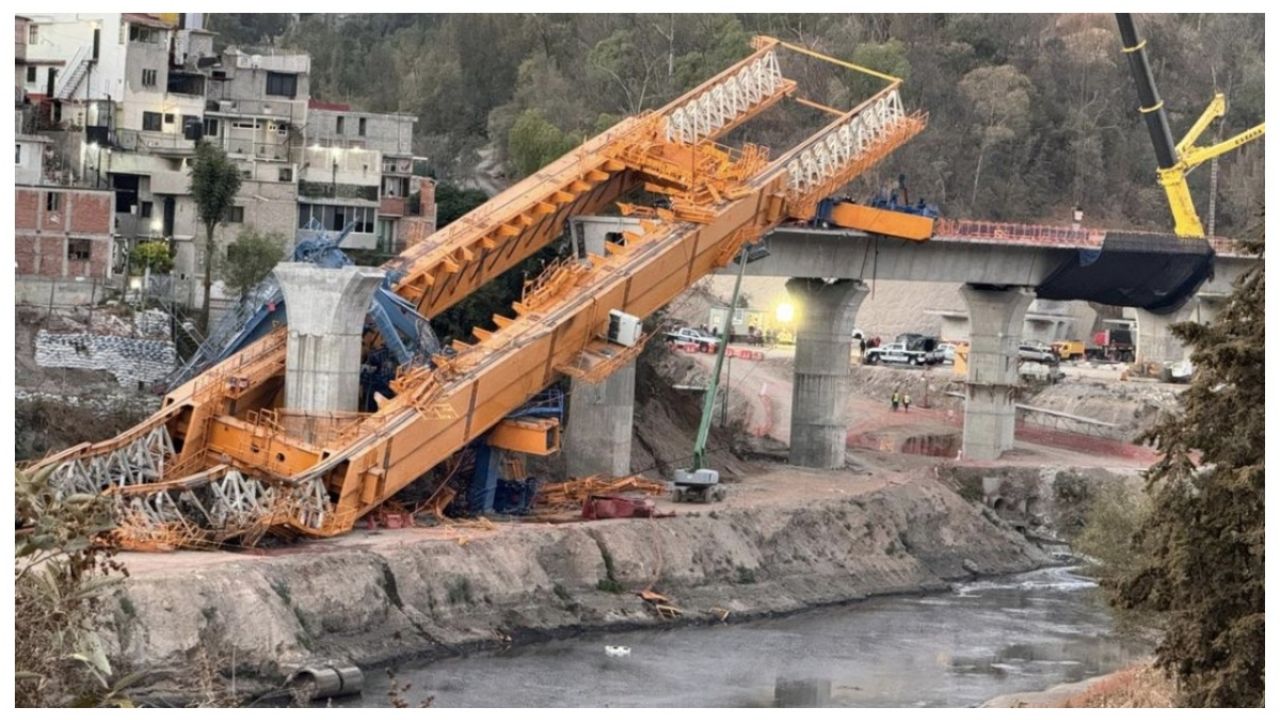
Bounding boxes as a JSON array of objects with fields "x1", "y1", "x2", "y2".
[{"x1": 40, "y1": 37, "x2": 925, "y2": 547}]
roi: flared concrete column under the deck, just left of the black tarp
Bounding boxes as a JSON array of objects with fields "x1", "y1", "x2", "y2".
[{"x1": 960, "y1": 284, "x2": 1036, "y2": 460}]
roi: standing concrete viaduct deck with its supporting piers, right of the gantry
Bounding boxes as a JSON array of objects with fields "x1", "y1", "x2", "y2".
[{"x1": 567, "y1": 212, "x2": 1257, "y2": 468}]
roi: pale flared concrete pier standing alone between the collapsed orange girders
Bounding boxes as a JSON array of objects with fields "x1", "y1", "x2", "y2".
[{"x1": 275, "y1": 263, "x2": 384, "y2": 413}]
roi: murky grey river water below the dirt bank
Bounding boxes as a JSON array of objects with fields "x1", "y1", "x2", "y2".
[{"x1": 344, "y1": 568, "x2": 1151, "y2": 707}]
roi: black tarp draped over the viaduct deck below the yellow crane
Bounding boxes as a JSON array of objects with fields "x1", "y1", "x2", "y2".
[{"x1": 1036, "y1": 232, "x2": 1213, "y2": 315}]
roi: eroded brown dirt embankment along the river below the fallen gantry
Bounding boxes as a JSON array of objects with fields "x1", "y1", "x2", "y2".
[{"x1": 104, "y1": 478, "x2": 1048, "y2": 688}]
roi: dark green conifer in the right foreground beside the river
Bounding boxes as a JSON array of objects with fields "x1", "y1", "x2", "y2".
[{"x1": 1116, "y1": 226, "x2": 1266, "y2": 707}]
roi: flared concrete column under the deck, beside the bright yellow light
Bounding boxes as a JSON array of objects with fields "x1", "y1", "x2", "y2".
[{"x1": 787, "y1": 278, "x2": 869, "y2": 468}]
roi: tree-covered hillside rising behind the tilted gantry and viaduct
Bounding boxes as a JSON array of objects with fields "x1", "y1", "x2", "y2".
[{"x1": 211, "y1": 14, "x2": 1265, "y2": 234}]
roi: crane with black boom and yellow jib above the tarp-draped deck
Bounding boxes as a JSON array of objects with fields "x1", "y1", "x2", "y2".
[{"x1": 1116, "y1": 13, "x2": 1266, "y2": 237}]
